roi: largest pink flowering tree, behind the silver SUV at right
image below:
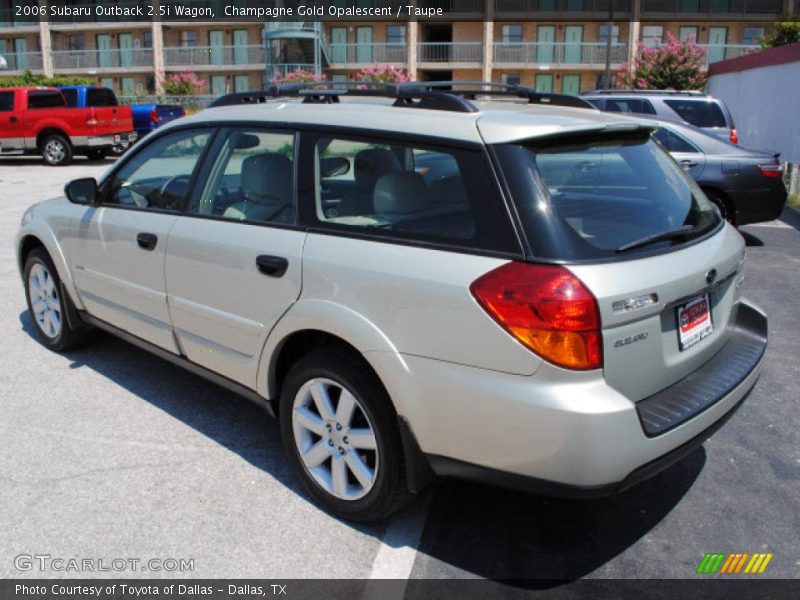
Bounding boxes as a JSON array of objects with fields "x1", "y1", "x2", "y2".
[{"x1": 619, "y1": 32, "x2": 707, "y2": 90}]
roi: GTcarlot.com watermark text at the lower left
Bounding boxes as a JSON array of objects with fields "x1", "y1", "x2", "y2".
[{"x1": 14, "y1": 554, "x2": 194, "y2": 573}]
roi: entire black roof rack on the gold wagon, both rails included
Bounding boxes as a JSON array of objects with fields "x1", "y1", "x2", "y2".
[{"x1": 210, "y1": 81, "x2": 596, "y2": 113}]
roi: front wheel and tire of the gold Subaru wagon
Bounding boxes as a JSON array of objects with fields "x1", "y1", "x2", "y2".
[{"x1": 25, "y1": 248, "x2": 87, "y2": 352}]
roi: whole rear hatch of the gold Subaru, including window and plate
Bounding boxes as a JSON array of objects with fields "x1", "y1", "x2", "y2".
[{"x1": 495, "y1": 128, "x2": 744, "y2": 401}]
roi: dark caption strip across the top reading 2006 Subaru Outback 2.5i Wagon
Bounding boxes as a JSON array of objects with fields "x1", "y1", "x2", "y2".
[{"x1": 0, "y1": 0, "x2": 788, "y2": 24}]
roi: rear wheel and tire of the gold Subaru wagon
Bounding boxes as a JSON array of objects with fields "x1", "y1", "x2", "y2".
[{"x1": 279, "y1": 348, "x2": 408, "y2": 521}]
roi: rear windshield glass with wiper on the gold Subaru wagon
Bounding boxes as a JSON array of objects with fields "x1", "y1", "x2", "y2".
[{"x1": 496, "y1": 132, "x2": 720, "y2": 260}]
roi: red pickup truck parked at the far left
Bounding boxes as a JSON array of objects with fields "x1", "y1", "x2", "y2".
[{"x1": 0, "y1": 87, "x2": 136, "y2": 165}]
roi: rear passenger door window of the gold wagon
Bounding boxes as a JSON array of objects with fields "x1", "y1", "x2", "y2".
[{"x1": 189, "y1": 128, "x2": 296, "y2": 224}]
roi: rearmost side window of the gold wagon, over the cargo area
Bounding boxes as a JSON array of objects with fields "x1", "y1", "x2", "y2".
[{"x1": 306, "y1": 137, "x2": 519, "y2": 252}]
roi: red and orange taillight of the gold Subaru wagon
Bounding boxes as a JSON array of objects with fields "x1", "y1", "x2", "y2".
[{"x1": 469, "y1": 262, "x2": 603, "y2": 370}]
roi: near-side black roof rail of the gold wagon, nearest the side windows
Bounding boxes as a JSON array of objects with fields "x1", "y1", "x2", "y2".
[{"x1": 210, "y1": 81, "x2": 478, "y2": 112}]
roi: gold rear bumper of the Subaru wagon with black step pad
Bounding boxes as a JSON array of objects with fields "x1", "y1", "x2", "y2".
[{"x1": 390, "y1": 301, "x2": 767, "y2": 497}]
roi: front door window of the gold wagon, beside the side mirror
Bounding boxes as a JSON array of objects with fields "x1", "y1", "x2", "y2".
[{"x1": 103, "y1": 129, "x2": 213, "y2": 211}]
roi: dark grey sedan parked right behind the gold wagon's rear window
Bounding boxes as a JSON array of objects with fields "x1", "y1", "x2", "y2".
[{"x1": 646, "y1": 118, "x2": 786, "y2": 225}]
